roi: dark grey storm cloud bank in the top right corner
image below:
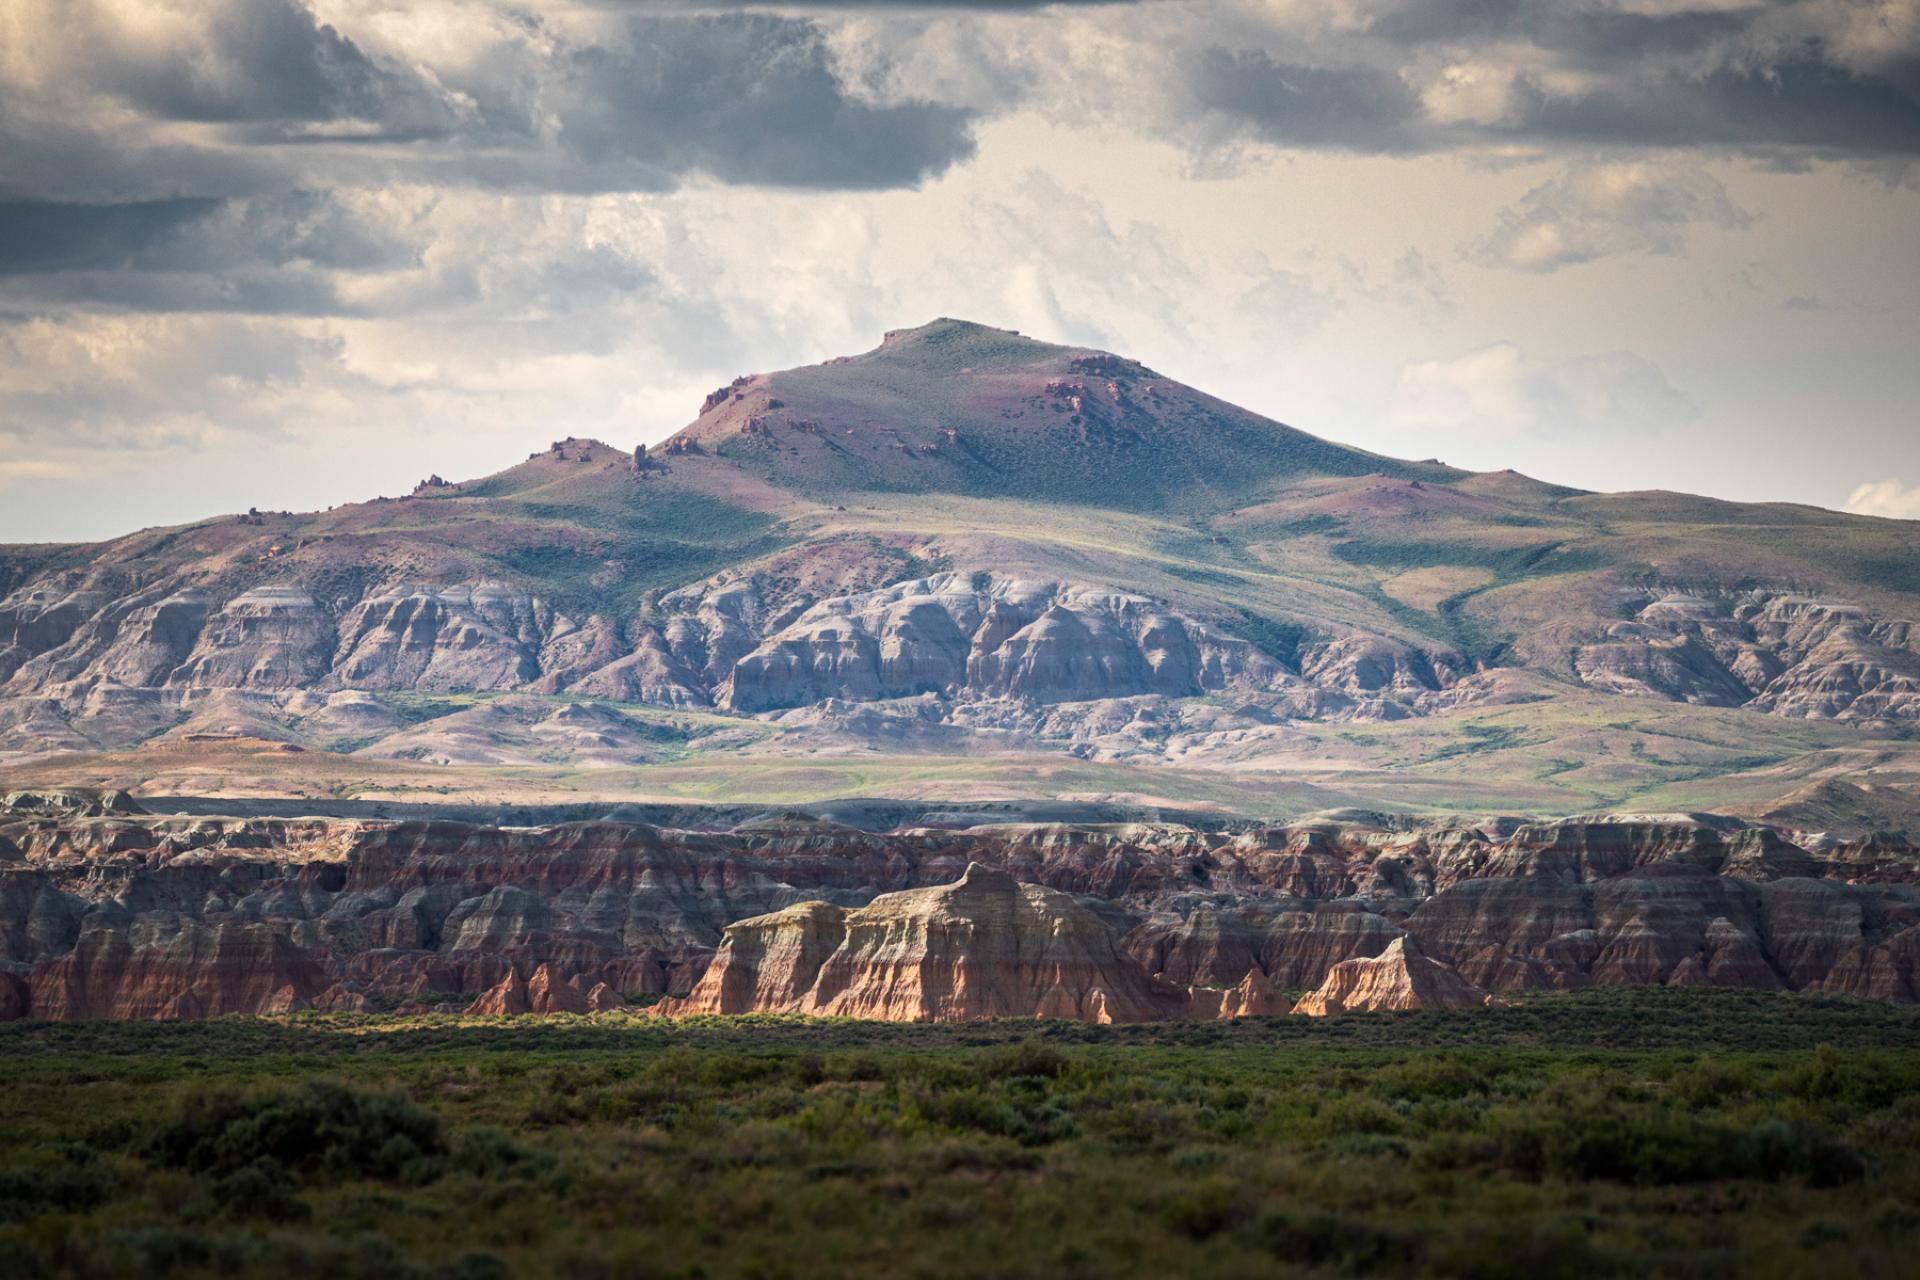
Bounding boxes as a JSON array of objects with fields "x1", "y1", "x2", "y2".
[{"x1": 1177, "y1": 0, "x2": 1920, "y2": 157}]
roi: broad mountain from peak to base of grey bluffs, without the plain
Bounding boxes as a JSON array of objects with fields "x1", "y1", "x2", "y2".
[{"x1": 0, "y1": 319, "x2": 1920, "y2": 758}]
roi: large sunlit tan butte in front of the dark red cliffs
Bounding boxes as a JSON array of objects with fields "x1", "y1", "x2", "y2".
[{"x1": 657, "y1": 864, "x2": 1187, "y2": 1023}]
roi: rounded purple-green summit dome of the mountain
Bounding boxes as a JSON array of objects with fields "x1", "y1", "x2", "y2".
[{"x1": 664, "y1": 317, "x2": 1413, "y2": 509}]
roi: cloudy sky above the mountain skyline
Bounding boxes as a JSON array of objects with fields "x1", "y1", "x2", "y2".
[{"x1": 0, "y1": 0, "x2": 1920, "y2": 541}]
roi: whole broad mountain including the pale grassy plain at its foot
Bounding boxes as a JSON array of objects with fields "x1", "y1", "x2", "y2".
[{"x1": 0, "y1": 320, "x2": 1920, "y2": 821}]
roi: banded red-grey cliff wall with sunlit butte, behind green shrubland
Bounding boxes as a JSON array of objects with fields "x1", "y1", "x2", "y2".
[{"x1": 0, "y1": 796, "x2": 1920, "y2": 1021}]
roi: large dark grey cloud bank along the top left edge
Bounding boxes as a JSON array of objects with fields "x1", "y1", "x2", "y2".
[{"x1": 0, "y1": 0, "x2": 975, "y2": 203}]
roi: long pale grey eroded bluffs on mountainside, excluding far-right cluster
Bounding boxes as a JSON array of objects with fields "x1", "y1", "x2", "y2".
[{"x1": 0, "y1": 566, "x2": 1457, "y2": 764}]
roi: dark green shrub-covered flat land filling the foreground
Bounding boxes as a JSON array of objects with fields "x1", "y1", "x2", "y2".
[{"x1": 0, "y1": 988, "x2": 1920, "y2": 1280}]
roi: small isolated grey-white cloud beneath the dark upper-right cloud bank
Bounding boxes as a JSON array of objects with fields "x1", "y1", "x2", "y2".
[{"x1": 1471, "y1": 163, "x2": 1753, "y2": 273}]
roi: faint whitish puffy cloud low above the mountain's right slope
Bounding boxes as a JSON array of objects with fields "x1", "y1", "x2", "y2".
[{"x1": 1388, "y1": 342, "x2": 1699, "y2": 436}]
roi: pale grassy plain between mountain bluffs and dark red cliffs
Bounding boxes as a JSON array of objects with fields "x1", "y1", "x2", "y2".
[{"x1": 6, "y1": 677, "x2": 1920, "y2": 829}]
